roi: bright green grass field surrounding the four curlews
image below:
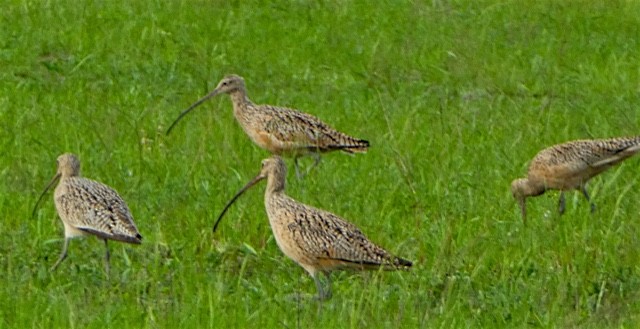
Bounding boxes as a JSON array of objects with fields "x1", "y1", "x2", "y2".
[{"x1": 0, "y1": 0, "x2": 640, "y2": 328}]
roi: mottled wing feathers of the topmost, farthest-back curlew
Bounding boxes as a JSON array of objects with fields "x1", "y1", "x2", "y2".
[{"x1": 261, "y1": 105, "x2": 369, "y2": 153}]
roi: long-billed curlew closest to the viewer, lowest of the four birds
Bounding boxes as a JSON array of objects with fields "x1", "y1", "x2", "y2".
[{"x1": 213, "y1": 156, "x2": 412, "y2": 300}]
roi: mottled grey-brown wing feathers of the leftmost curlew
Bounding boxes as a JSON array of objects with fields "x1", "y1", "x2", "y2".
[{"x1": 56, "y1": 177, "x2": 142, "y2": 243}]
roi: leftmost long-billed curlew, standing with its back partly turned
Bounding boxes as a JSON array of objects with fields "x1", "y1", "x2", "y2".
[{"x1": 33, "y1": 153, "x2": 142, "y2": 276}]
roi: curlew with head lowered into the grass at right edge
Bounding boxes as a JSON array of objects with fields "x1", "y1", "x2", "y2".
[{"x1": 511, "y1": 136, "x2": 640, "y2": 223}]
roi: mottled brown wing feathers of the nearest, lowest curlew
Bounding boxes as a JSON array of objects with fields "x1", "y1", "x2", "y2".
[{"x1": 288, "y1": 204, "x2": 411, "y2": 269}]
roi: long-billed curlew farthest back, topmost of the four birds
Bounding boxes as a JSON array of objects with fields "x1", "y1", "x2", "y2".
[{"x1": 167, "y1": 75, "x2": 369, "y2": 176}]
